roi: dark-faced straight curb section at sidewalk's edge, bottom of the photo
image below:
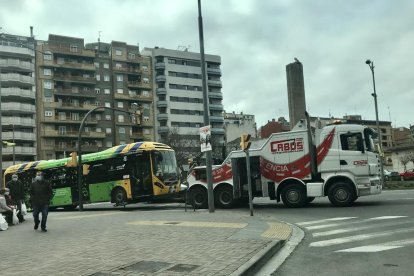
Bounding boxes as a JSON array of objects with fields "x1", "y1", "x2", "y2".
[{"x1": 230, "y1": 240, "x2": 286, "y2": 276}]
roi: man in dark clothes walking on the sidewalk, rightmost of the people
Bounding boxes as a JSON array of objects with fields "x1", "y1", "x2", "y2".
[{"x1": 30, "y1": 171, "x2": 52, "y2": 232}]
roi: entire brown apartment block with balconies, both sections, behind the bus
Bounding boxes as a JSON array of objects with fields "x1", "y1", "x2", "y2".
[{"x1": 36, "y1": 35, "x2": 153, "y2": 159}]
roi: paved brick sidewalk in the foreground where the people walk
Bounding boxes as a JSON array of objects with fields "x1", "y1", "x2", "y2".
[{"x1": 0, "y1": 205, "x2": 292, "y2": 276}]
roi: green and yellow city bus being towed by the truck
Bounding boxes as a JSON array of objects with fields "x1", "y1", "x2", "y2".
[{"x1": 3, "y1": 142, "x2": 181, "y2": 209}]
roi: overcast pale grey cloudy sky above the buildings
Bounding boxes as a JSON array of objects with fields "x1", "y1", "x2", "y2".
[{"x1": 0, "y1": 0, "x2": 414, "y2": 127}]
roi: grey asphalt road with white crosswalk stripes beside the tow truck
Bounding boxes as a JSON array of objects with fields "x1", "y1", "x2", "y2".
[{"x1": 255, "y1": 190, "x2": 414, "y2": 276}]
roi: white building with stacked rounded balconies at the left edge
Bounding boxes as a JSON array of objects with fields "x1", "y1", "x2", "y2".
[{"x1": 0, "y1": 30, "x2": 36, "y2": 169}]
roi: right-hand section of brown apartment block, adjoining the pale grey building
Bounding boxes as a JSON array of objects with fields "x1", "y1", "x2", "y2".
[{"x1": 86, "y1": 41, "x2": 155, "y2": 147}]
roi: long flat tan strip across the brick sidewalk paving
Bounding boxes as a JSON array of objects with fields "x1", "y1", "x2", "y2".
[{"x1": 127, "y1": 220, "x2": 247, "y2": 229}]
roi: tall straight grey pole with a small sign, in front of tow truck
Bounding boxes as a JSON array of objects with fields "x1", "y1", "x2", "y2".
[{"x1": 198, "y1": 0, "x2": 214, "y2": 213}]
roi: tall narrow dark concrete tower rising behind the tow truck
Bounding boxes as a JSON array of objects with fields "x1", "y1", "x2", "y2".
[{"x1": 286, "y1": 58, "x2": 306, "y2": 128}]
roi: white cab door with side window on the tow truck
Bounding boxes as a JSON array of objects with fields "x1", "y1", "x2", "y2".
[{"x1": 339, "y1": 131, "x2": 369, "y2": 177}]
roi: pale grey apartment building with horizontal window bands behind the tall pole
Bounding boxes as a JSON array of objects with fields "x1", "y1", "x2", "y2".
[{"x1": 142, "y1": 47, "x2": 224, "y2": 151}]
